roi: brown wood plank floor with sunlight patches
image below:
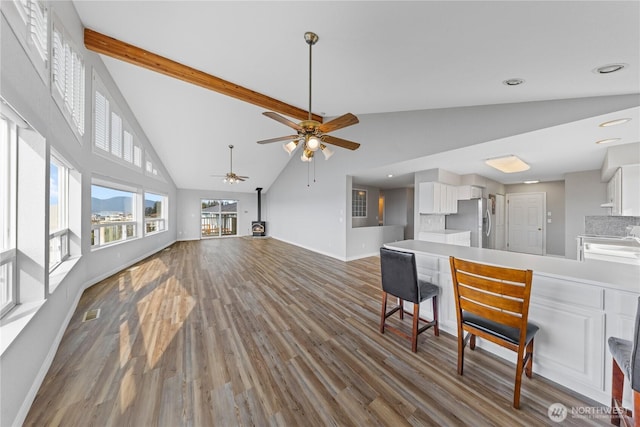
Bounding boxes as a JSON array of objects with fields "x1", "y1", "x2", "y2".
[{"x1": 25, "y1": 238, "x2": 607, "y2": 426}]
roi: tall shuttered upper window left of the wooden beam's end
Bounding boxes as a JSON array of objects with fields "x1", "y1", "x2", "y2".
[{"x1": 51, "y1": 22, "x2": 85, "y2": 136}]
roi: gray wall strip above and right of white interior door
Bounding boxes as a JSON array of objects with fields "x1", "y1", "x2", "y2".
[{"x1": 505, "y1": 181, "x2": 564, "y2": 256}]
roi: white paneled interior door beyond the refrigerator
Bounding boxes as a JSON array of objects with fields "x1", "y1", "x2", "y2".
[{"x1": 507, "y1": 193, "x2": 546, "y2": 255}]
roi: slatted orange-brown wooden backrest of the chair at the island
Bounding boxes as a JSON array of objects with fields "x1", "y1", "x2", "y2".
[{"x1": 449, "y1": 257, "x2": 533, "y2": 342}]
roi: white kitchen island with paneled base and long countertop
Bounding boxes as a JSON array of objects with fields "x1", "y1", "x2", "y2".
[{"x1": 385, "y1": 240, "x2": 640, "y2": 405}]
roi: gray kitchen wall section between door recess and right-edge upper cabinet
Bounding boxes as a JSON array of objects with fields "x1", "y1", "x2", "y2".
[{"x1": 564, "y1": 170, "x2": 607, "y2": 259}]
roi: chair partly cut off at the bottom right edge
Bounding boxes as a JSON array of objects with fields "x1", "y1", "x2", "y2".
[{"x1": 609, "y1": 298, "x2": 640, "y2": 427}]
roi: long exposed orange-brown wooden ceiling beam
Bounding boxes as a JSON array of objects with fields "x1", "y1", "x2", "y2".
[{"x1": 84, "y1": 28, "x2": 322, "y2": 123}]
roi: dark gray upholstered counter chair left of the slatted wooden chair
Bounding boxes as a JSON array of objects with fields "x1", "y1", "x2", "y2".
[{"x1": 380, "y1": 248, "x2": 440, "y2": 353}]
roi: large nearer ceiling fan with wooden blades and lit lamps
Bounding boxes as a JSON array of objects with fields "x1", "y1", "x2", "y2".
[{"x1": 258, "y1": 32, "x2": 360, "y2": 162}]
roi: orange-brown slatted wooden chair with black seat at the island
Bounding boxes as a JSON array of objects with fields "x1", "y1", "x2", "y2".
[{"x1": 449, "y1": 257, "x2": 538, "y2": 409}]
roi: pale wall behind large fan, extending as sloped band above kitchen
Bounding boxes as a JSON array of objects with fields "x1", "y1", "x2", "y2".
[{"x1": 268, "y1": 95, "x2": 638, "y2": 259}]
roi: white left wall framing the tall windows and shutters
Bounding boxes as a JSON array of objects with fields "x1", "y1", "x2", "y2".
[{"x1": 0, "y1": 1, "x2": 177, "y2": 426}]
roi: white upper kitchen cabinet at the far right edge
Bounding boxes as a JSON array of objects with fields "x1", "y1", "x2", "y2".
[{"x1": 602, "y1": 164, "x2": 640, "y2": 216}]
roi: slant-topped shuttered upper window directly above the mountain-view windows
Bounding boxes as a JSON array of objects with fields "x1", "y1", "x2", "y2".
[{"x1": 93, "y1": 73, "x2": 142, "y2": 170}]
